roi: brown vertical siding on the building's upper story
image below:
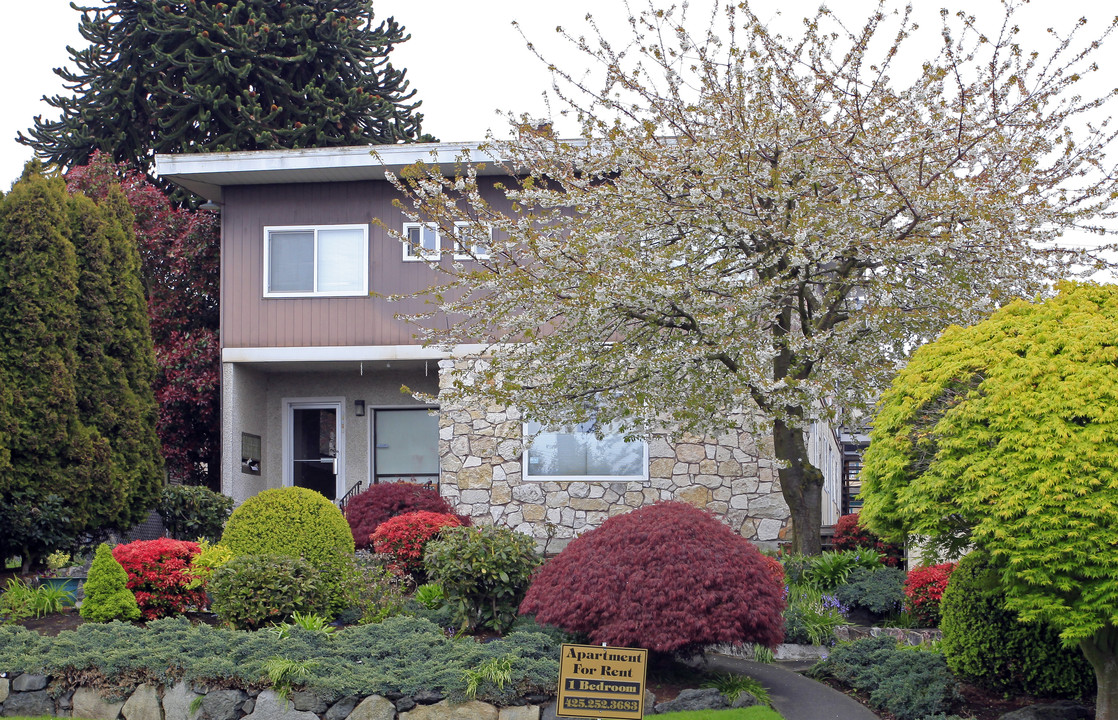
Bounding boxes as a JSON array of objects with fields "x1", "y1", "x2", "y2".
[{"x1": 221, "y1": 181, "x2": 509, "y2": 348}]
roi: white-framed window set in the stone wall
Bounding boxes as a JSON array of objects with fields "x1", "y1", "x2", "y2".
[{"x1": 523, "y1": 421, "x2": 648, "y2": 482}]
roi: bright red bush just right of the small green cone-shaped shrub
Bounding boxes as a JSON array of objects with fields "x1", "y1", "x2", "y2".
[{"x1": 113, "y1": 538, "x2": 206, "y2": 620}]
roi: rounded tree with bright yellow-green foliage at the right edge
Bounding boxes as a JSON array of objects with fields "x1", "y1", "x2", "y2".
[{"x1": 861, "y1": 283, "x2": 1118, "y2": 720}]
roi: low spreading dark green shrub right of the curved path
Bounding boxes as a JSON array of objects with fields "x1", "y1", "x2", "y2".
[{"x1": 808, "y1": 636, "x2": 958, "y2": 720}]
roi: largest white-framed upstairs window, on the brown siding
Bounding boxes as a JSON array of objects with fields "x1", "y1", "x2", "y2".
[{"x1": 264, "y1": 225, "x2": 369, "y2": 297}]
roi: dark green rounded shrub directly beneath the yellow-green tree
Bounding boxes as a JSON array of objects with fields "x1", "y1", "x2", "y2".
[{"x1": 939, "y1": 552, "x2": 1096, "y2": 698}]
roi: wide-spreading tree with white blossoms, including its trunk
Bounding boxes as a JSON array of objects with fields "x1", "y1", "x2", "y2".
[{"x1": 397, "y1": 3, "x2": 1118, "y2": 552}]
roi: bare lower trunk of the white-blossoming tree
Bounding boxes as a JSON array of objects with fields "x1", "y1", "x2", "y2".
[{"x1": 773, "y1": 420, "x2": 823, "y2": 555}]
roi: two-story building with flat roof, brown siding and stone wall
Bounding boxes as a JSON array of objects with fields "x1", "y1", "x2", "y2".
[{"x1": 157, "y1": 143, "x2": 842, "y2": 550}]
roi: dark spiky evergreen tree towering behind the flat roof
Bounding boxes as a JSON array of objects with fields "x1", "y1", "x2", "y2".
[{"x1": 19, "y1": 0, "x2": 431, "y2": 183}]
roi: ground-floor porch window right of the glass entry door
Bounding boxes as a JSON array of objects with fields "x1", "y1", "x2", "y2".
[{"x1": 373, "y1": 409, "x2": 438, "y2": 485}]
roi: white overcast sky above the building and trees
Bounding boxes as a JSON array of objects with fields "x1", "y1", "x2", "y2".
[{"x1": 0, "y1": 0, "x2": 1118, "y2": 258}]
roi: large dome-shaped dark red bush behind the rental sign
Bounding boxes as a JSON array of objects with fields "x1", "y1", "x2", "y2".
[{"x1": 520, "y1": 502, "x2": 784, "y2": 652}]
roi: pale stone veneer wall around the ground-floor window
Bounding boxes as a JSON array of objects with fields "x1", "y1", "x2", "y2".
[{"x1": 438, "y1": 359, "x2": 790, "y2": 552}]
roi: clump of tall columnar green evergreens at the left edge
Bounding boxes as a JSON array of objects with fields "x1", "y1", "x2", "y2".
[{"x1": 0, "y1": 162, "x2": 162, "y2": 566}]
